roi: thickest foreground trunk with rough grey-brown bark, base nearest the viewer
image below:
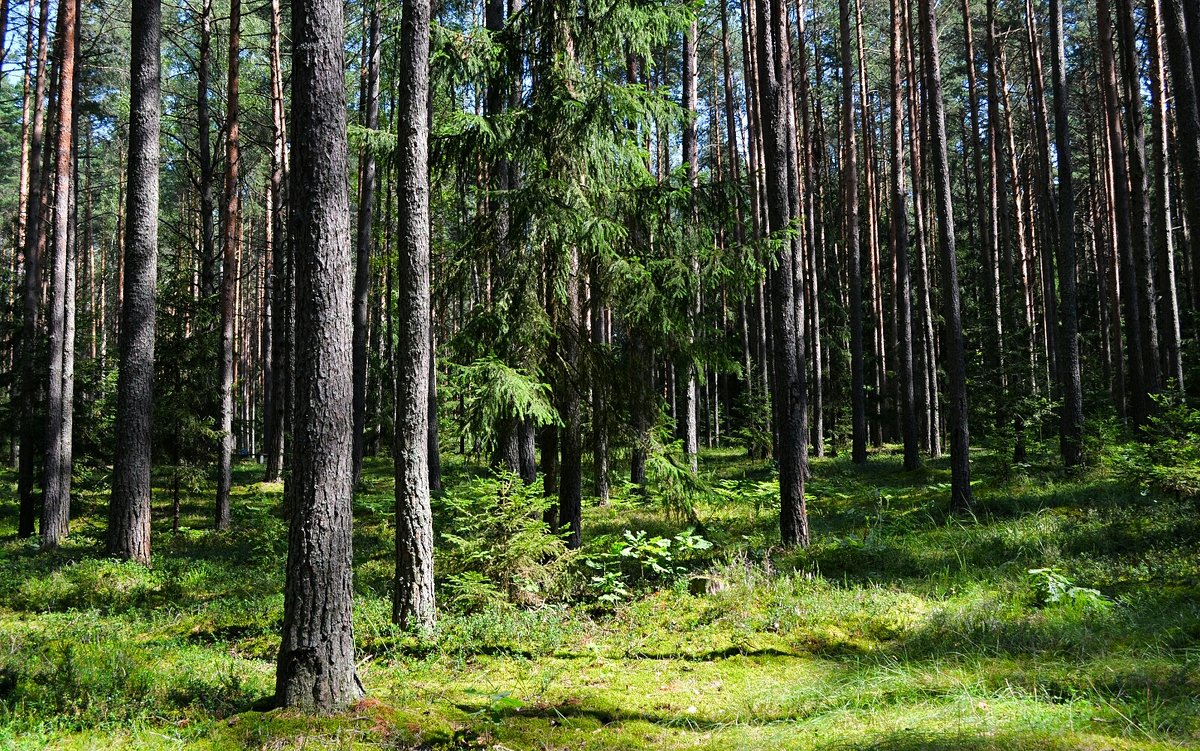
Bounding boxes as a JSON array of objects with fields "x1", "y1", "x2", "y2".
[{"x1": 275, "y1": 0, "x2": 360, "y2": 711}]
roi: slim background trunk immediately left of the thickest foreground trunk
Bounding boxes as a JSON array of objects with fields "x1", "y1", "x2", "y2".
[{"x1": 263, "y1": 0, "x2": 294, "y2": 482}]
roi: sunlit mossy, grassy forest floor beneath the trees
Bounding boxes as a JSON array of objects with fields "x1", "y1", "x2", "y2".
[{"x1": 0, "y1": 447, "x2": 1200, "y2": 751}]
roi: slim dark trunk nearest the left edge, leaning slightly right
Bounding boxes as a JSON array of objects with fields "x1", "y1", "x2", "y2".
[{"x1": 17, "y1": 0, "x2": 49, "y2": 537}]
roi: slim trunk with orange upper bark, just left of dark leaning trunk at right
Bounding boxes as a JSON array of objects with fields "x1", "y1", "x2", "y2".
[{"x1": 890, "y1": 0, "x2": 920, "y2": 470}]
